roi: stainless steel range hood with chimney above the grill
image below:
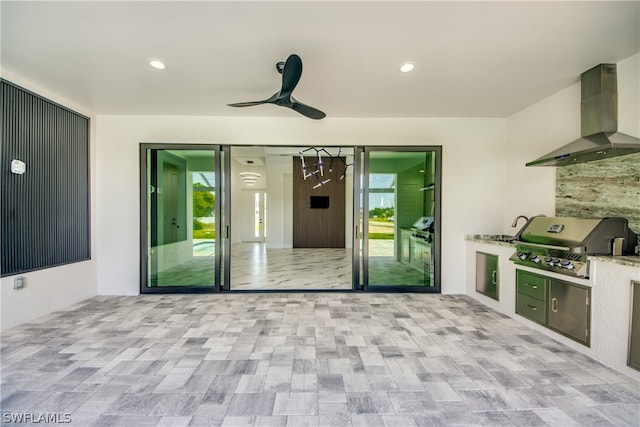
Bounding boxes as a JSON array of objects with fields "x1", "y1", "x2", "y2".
[{"x1": 527, "y1": 64, "x2": 640, "y2": 166}]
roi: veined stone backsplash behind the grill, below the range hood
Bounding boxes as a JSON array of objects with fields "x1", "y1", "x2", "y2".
[{"x1": 556, "y1": 153, "x2": 640, "y2": 233}]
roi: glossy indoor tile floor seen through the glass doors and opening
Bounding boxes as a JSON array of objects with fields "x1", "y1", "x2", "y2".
[{"x1": 156, "y1": 240, "x2": 434, "y2": 291}]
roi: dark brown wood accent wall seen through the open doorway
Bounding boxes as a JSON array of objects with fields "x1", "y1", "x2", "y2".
[{"x1": 293, "y1": 157, "x2": 345, "y2": 248}]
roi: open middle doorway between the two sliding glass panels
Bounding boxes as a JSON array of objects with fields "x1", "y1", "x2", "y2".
[{"x1": 229, "y1": 146, "x2": 354, "y2": 291}]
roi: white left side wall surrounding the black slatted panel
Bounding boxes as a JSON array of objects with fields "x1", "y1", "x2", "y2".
[{"x1": 0, "y1": 70, "x2": 98, "y2": 330}]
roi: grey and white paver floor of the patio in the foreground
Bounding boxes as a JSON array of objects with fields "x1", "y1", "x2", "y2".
[{"x1": 0, "y1": 292, "x2": 640, "y2": 427}]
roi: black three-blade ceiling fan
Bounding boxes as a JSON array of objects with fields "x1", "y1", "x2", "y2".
[{"x1": 227, "y1": 54, "x2": 326, "y2": 120}]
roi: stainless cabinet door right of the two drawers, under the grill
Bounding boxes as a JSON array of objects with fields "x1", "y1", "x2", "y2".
[{"x1": 548, "y1": 280, "x2": 591, "y2": 346}]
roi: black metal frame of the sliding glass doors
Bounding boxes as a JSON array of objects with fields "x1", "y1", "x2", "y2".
[{"x1": 140, "y1": 143, "x2": 442, "y2": 294}]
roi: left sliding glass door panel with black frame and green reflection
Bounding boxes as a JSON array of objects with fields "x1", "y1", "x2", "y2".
[{"x1": 140, "y1": 144, "x2": 228, "y2": 293}]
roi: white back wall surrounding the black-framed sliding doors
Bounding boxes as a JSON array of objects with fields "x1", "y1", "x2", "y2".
[{"x1": 95, "y1": 116, "x2": 510, "y2": 295}]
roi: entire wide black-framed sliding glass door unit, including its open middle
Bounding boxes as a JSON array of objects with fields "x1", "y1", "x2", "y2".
[{"x1": 140, "y1": 144, "x2": 441, "y2": 293}]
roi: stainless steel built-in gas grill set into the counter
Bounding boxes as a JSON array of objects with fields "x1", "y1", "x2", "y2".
[{"x1": 510, "y1": 216, "x2": 638, "y2": 278}]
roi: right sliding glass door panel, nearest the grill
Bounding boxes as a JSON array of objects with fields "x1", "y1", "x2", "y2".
[{"x1": 356, "y1": 147, "x2": 441, "y2": 292}]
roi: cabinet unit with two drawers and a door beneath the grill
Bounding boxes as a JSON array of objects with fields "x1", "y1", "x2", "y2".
[{"x1": 516, "y1": 270, "x2": 591, "y2": 346}]
